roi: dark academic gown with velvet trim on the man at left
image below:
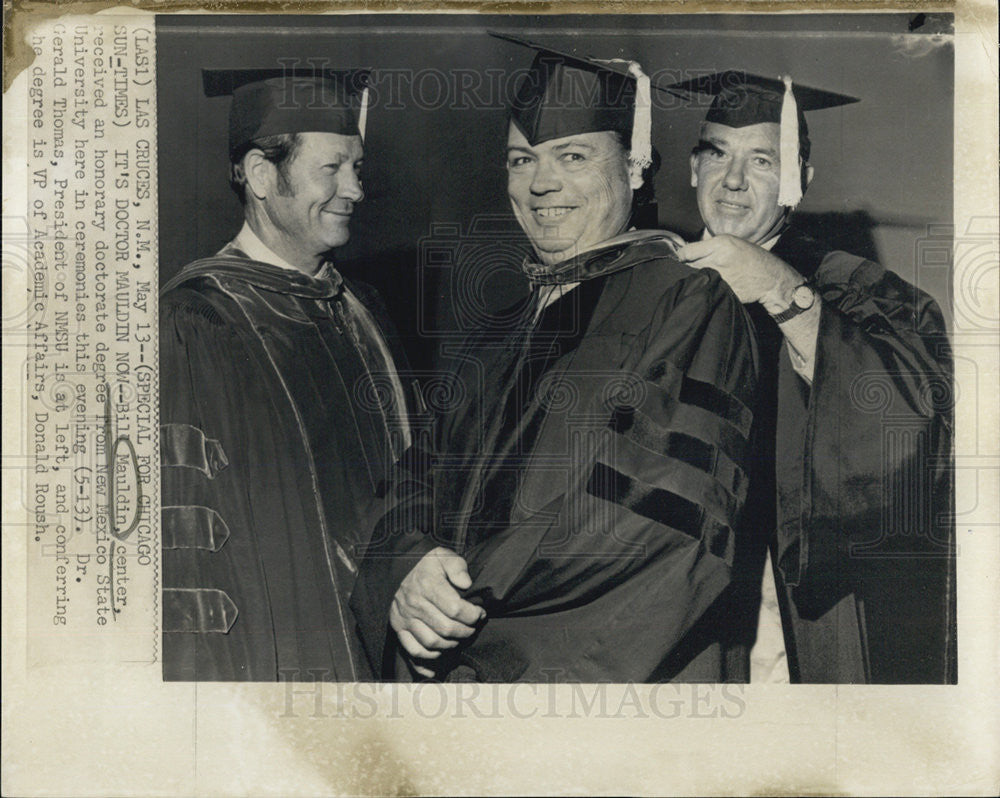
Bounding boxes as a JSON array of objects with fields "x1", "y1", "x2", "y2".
[{"x1": 160, "y1": 247, "x2": 402, "y2": 681}]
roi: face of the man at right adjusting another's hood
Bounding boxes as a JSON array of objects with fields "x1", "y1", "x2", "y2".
[{"x1": 691, "y1": 122, "x2": 785, "y2": 244}]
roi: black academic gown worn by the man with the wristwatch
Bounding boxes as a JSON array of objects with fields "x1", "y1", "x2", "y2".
[{"x1": 751, "y1": 227, "x2": 956, "y2": 683}]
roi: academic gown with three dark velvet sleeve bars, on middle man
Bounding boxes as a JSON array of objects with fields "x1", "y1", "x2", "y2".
[{"x1": 352, "y1": 233, "x2": 757, "y2": 682}]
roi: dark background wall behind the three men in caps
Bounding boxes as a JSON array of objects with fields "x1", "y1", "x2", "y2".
[{"x1": 157, "y1": 14, "x2": 954, "y2": 366}]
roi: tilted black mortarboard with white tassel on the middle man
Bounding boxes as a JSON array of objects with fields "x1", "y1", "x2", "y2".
[{"x1": 490, "y1": 31, "x2": 667, "y2": 167}]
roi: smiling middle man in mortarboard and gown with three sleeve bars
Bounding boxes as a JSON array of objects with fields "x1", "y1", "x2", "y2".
[{"x1": 352, "y1": 37, "x2": 756, "y2": 682}]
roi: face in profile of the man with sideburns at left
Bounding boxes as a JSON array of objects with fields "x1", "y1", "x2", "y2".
[{"x1": 264, "y1": 133, "x2": 364, "y2": 266}]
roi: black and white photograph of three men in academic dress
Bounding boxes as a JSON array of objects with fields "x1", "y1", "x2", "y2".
[{"x1": 157, "y1": 15, "x2": 957, "y2": 684}]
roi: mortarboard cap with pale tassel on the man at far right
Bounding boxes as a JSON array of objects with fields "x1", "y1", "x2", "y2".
[{"x1": 670, "y1": 69, "x2": 858, "y2": 206}]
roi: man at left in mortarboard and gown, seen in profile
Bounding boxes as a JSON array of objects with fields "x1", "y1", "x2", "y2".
[{"x1": 160, "y1": 69, "x2": 409, "y2": 681}]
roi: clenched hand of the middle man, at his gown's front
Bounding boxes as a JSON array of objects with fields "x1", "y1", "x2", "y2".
[{"x1": 389, "y1": 546, "x2": 486, "y2": 676}]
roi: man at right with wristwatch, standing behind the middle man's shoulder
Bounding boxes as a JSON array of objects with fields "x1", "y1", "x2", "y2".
[{"x1": 672, "y1": 71, "x2": 956, "y2": 683}]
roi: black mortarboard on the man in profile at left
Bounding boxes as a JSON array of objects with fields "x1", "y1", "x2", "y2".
[{"x1": 202, "y1": 68, "x2": 369, "y2": 160}]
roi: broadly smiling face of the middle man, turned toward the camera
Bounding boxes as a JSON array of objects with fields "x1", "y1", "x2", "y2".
[{"x1": 507, "y1": 123, "x2": 641, "y2": 265}]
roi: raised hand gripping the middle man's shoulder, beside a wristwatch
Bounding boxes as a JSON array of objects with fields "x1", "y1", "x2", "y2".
[{"x1": 677, "y1": 235, "x2": 802, "y2": 315}]
